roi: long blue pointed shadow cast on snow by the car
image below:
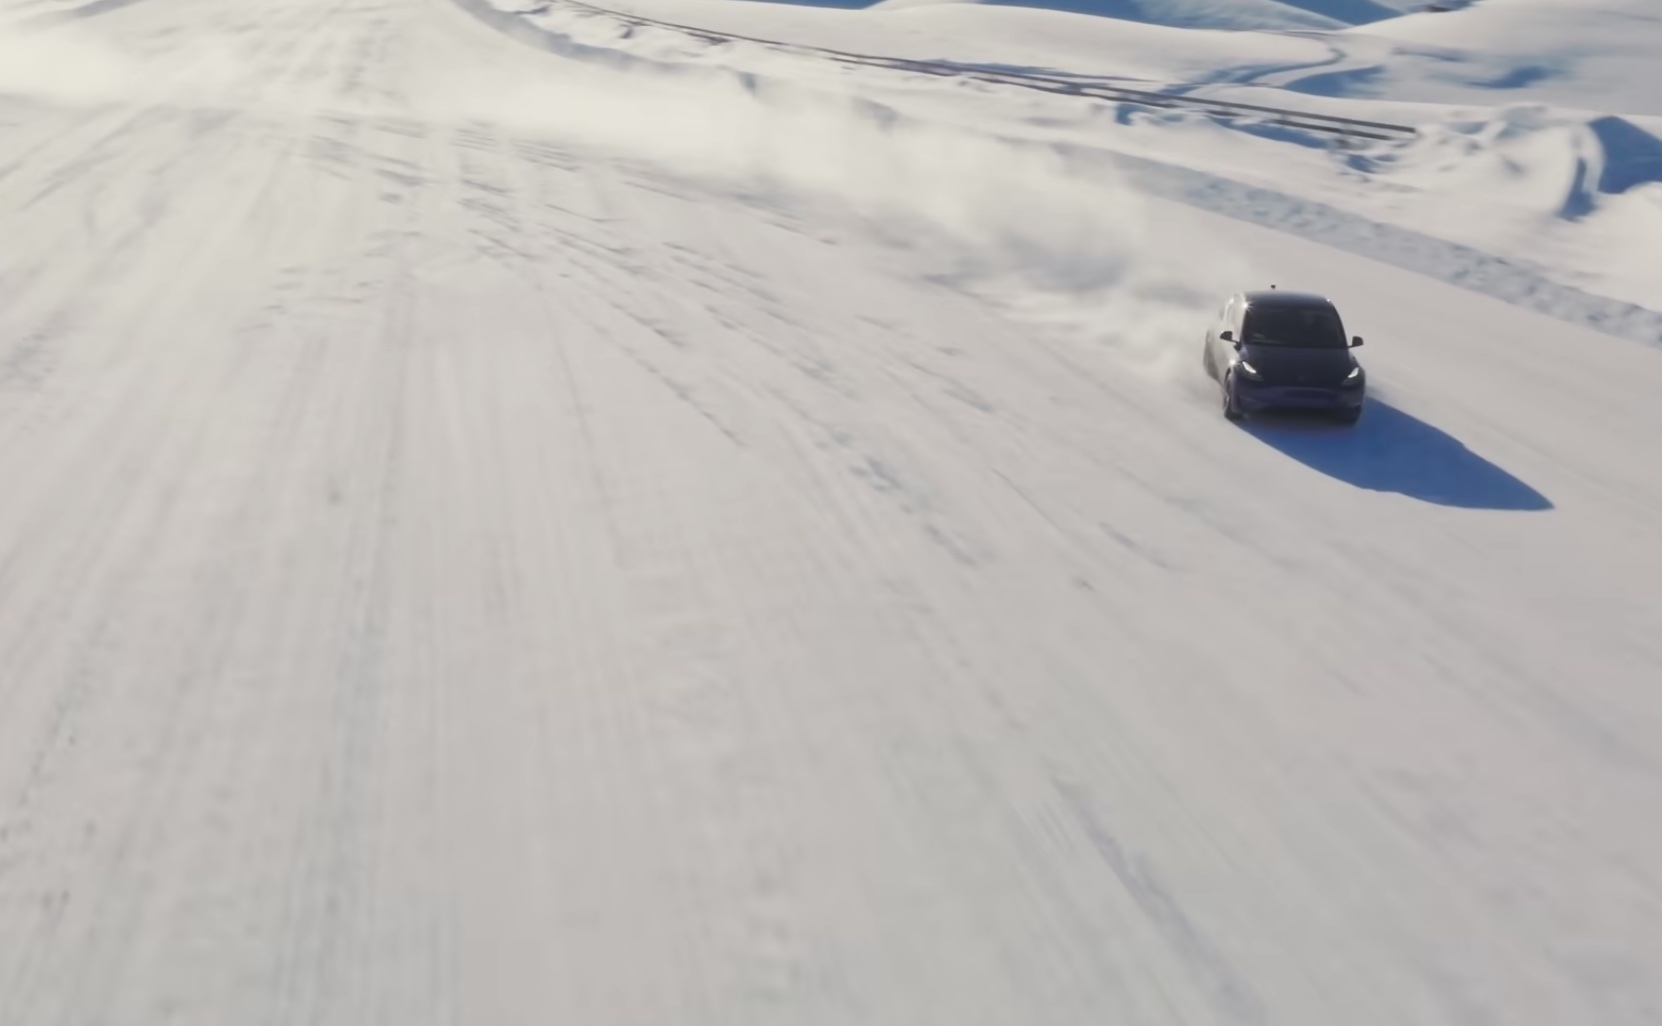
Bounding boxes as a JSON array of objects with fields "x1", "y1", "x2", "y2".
[{"x1": 1243, "y1": 396, "x2": 1552, "y2": 511}]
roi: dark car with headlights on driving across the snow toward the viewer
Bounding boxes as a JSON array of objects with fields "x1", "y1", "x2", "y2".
[{"x1": 1205, "y1": 288, "x2": 1368, "y2": 424}]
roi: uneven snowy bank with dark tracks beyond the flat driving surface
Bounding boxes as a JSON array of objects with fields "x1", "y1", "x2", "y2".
[{"x1": 505, "y1": 0, "x2": 1662, "y2": 311}]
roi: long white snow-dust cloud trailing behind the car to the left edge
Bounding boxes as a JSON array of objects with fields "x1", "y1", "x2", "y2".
[{"x1": 0, "y1": 4, "x2": 1240, "y2": 382}]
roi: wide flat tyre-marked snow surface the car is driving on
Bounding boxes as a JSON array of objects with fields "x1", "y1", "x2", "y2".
[{"x1": 0, "y1": 0, "x2": 1662, "y2": 1026}]
